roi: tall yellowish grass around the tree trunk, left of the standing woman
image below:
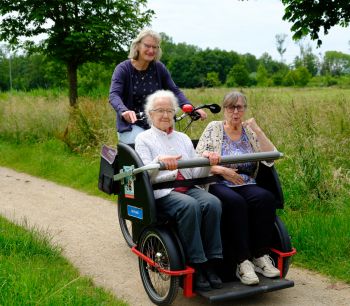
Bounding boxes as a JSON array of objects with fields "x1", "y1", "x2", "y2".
[{"x1": 0, "y1": 92, "x2": 116, "y2": 153}]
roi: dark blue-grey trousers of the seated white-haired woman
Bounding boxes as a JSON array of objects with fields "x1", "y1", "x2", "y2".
[{"x1": 156, "y1": 188, "x2": 222, "y2": 263}]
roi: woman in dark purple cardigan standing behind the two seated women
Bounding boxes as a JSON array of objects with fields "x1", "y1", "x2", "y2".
[{"x1": 109, "y1": 29, "x2": 207, "y2": 143}]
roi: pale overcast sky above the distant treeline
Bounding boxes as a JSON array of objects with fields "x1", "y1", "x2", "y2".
[{"x1": 148, "y1": 0, "x2": 350, "y2": 63}]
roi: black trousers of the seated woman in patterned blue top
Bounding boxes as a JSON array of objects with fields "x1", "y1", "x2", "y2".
[{"x1": 209, "y1": 184, "x2": 276, "y2": 262}]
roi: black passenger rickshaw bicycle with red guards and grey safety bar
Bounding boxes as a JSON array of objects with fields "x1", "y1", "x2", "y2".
[{"x1": 99, "y1": 104, "x2": 296, "y2": 305}]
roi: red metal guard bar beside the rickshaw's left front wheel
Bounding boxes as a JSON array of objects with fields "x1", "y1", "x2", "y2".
[{"x1": 131, "y1": 246, "x2": 196, "y2": 298}]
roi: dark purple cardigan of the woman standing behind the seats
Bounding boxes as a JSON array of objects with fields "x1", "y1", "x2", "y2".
[{"x1": 109, "y1": 60, "x2": 191, "y2": 133}]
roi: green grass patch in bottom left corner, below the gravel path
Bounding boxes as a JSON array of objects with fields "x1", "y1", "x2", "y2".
[{"x1": 0, "y1": 216, "x2": 127, "y2": 305}]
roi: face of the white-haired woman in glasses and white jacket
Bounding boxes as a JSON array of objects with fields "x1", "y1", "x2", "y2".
[{"x1": 150, "y1": 97, "x2": 175, "y2": 132}]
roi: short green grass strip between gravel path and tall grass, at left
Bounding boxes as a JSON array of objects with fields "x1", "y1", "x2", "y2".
[{"x1": 0, "y1": 139, "x2": 107, "y2": 198}]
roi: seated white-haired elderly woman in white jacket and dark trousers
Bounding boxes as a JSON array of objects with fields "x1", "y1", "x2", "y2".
[{"x1": 135, "y1": 90, "x2": 222, "y2": 290}]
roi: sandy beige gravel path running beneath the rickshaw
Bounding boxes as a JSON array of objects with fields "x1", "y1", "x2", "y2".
[{"x1": 0, "y1": 167, "x2": 350, "y2": 306}]
